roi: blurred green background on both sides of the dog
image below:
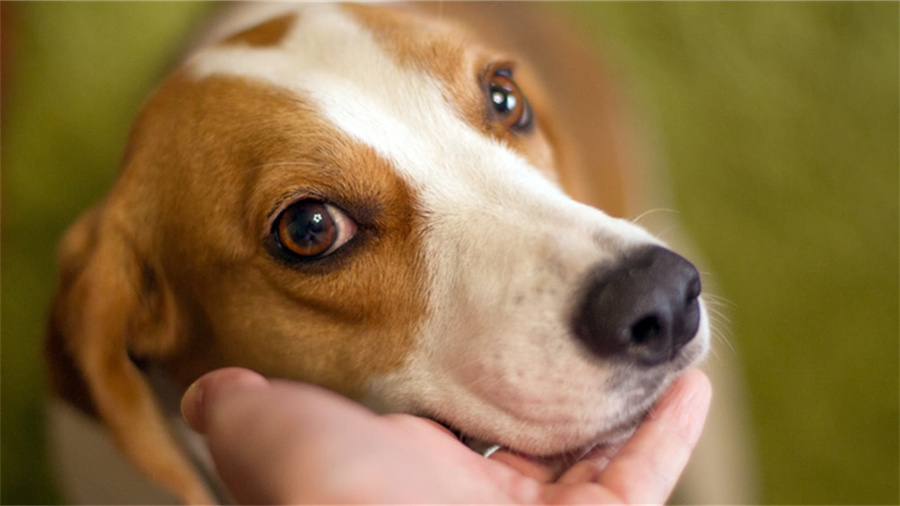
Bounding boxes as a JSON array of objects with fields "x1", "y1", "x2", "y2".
[{"x1": 0, "y1": 2, "x2": 900, "y2": 504}]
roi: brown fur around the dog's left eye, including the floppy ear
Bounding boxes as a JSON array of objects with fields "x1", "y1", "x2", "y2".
[{"x1": 48, "y1": 68, "x2": 432, "y2": 502}]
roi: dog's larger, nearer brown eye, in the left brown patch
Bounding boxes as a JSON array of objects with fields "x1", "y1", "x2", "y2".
[{"x1": 272, "y1": 199, "x2": 356, "y2": 259}]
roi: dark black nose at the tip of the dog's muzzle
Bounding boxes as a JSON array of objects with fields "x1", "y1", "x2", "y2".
[{"x1": 574, "y1": 246, "x2": 700, "y2": 365}]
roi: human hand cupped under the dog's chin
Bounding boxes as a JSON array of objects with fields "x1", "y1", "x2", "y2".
[{"x1": 182, "y1": 368, "x2": 712, "y2": 504}]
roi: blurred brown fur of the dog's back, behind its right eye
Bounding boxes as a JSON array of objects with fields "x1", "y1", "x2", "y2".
[{"x1": 414, "y1": 1, "x2": 641, "y2": 213}]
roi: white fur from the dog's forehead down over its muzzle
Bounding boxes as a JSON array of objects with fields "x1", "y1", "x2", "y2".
[{"x1": 190, "y1": 4, "x2": 708, "y2": 454}]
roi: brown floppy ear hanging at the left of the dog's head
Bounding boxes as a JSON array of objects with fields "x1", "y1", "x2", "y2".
[{"x1": 46, "y1": 204, "x2": 213, "y2": 503}]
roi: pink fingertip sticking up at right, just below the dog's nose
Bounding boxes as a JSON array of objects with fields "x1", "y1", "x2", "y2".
[{"x1": 597, "y1": 370, "x2": 712, "y2": 504}]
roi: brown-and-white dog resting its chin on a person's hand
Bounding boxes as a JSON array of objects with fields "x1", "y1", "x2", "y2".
[{"x1": 46, "y1": 3, "x2": 709, "y2": 503}]
